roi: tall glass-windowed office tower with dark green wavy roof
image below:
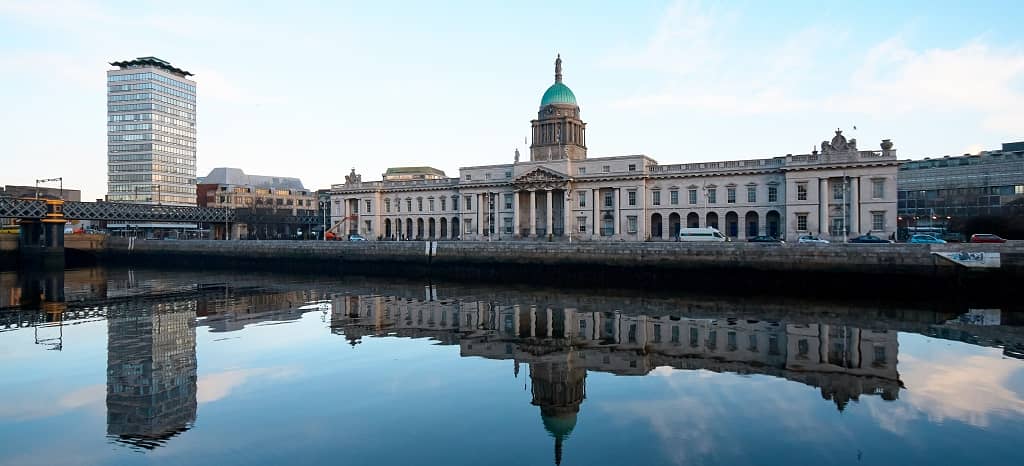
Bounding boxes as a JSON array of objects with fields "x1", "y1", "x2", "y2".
[{"x1": 106, "y1": 56, "x2": 196, "y2": 206}]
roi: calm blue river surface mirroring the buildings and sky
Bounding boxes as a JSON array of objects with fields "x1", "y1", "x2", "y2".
[{"x1": 0, "y1": 269, "x2": 1024, "y2": 466}]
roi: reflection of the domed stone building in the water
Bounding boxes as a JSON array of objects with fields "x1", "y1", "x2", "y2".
[{"x1": 331, "y1": 292, "x2": 902, "y2": 464}]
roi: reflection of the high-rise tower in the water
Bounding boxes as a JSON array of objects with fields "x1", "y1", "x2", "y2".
[{"x1": 106, "y1": 300, "x2": 197, "y2": 450}]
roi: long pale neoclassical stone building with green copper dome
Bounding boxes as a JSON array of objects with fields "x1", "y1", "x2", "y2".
[{"x1": 331, "y1": 57, "x2": 899, "y2": 241}]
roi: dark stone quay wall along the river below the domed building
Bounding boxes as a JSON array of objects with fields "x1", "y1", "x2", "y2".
[{"x1": 90, "y1": 239, "x2": 1024, "y2": 295}]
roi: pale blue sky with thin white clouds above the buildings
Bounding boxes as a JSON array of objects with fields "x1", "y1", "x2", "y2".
[{"x1": 0, "y1": 0, "x2": 1024, "y2": 200}]
